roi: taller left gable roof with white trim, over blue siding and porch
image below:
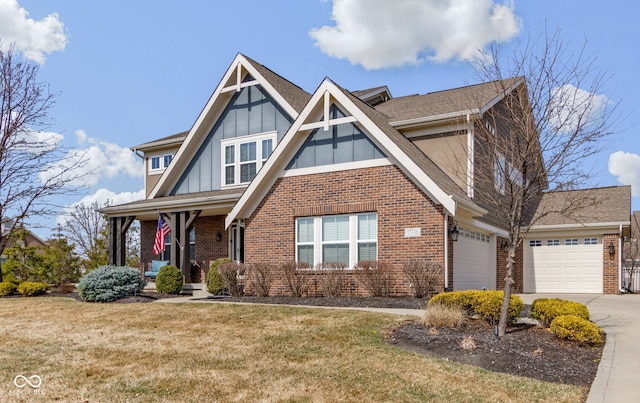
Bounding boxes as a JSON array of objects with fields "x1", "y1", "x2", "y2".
[{"x1": 148, "y1": 53, "x2": 310, "y2": 199}]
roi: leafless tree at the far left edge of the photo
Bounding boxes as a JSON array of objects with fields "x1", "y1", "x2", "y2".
[{"x1": 0, "y1": 40, "x2": 84, "y2": 280}]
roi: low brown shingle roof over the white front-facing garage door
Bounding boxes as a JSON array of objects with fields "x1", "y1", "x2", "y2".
[{"x1": 532, "y1": 186, "x2": 631, "y2": 228}]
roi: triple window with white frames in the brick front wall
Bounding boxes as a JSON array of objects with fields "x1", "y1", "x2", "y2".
[{"x1": 296, "y1": 213, "x2": 378, "y2": 267}]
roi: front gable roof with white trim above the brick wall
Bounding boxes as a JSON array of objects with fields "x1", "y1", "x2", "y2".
[{"x1": 226, "y1": 79, "x2": 486, "y2": 227}]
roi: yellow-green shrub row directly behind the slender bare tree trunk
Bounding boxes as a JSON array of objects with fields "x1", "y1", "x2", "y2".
[{"x1": 429, "y1": 290, "x2": 524, "y2": 323}]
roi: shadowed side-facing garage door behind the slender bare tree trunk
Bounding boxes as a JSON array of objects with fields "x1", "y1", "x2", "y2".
[{"x1": 453, "y1": 228, "x2": 496, "y2": 290}]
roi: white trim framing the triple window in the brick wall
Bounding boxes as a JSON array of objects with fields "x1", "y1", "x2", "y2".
[{"x1": 295, "y1": 212, "x2": 379, "y2": 269}]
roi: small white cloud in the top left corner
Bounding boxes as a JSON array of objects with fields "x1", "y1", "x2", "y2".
[{"x1": 0, "y1": 0, "x2": 67, "y2": 64}]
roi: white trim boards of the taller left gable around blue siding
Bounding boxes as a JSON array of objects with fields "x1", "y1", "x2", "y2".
[{"x1": 147, "y1": 54, "x2": 298, "y2": 199}]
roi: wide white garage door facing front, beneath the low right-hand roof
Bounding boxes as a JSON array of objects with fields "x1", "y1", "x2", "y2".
[{"x1": 524, "y1": 237, "x2": 603, "y2": 293}]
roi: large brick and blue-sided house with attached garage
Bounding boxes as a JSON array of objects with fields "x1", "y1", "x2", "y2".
[{"x1": 101, "y1": 55, "x2": 630, "y2": 295}]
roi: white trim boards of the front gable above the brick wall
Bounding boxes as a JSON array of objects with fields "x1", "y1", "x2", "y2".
[{"x1": 225, "y1": 79, "x2": 456, "y2": 227}]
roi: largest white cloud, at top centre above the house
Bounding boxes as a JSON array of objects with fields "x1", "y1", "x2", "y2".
[{"x1": 309, "y1": 0, "x2": 521, "y2": 69}]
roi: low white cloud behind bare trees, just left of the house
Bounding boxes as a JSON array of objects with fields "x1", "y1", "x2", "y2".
[{"x1": 40, "y1": 130, "x2": 144, "y2": 187}]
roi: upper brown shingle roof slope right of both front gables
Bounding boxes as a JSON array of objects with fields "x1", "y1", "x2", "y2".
[{"x1": 375, "y1": 77, "x2": 524, "y2": 126}]
